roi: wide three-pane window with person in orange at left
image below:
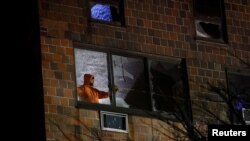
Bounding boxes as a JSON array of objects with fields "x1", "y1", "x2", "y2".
[{"x1": 74, "y1": 48, "x2": 189, "y2": 116}]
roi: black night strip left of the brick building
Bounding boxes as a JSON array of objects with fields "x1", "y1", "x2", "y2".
[{"x1": 1, "y1": 0, "x2": 46, "y2": 141}]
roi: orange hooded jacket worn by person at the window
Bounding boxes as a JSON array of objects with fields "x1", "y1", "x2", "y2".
[{"x1": 77, "y1": 74, "x2": 109, "y2": 103}]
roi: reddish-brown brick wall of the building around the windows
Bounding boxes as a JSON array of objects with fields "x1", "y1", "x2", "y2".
[{"x1": 39, "y1": 0, "x2": 250, "y2": 141}]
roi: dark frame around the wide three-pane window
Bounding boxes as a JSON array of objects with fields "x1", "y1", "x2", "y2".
[{"x1": 73, "y1": 43, "x2": 192, "y2": 119}]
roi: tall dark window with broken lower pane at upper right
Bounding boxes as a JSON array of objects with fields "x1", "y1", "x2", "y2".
[{"x1": 194, "y1": 0, "x2": 227, "y2": 42}]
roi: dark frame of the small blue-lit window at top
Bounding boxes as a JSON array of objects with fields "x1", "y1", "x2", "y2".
[{"x1": 88, "y1": 0, "x2": 125, "y2": 27}]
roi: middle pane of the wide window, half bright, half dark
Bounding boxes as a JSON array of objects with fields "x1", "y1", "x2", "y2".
[{"x1": 112, "y1": 55, "x2": 150, "y2": 109}]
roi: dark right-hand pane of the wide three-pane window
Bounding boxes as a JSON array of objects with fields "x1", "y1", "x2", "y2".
[{"x1": 149, "y1": 60, "x2": 187, "y2": 112}]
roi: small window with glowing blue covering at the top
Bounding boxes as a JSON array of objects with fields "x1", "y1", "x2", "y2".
[{"x1": 89, "y1": 0, "x2": 125, "y2": 26}]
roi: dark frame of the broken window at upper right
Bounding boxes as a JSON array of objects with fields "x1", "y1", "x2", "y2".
[{"x1": 193, "y1": 0, "x2": 228, "y2": 44}]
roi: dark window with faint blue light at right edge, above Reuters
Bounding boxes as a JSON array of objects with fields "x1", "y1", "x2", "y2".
[{"x1": 227, "y1": 69, "x2": 250, "y2": 123}]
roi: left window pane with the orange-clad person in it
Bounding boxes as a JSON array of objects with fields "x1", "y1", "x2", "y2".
[{"x1": 75, "y1": 49, "x2": 110, "y2": 104}]
